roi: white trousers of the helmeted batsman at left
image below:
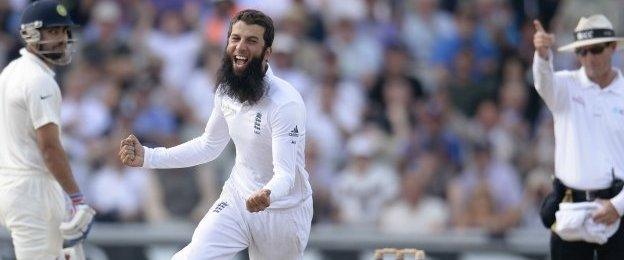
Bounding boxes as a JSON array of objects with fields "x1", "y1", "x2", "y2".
[{"x1": 0, "y1": 172, "x2": 65, "y2": 260}]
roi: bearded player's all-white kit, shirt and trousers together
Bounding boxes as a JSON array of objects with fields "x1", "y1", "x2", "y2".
[{"x1": 144, "y1": 68, "x2": 312, "y2": 259}]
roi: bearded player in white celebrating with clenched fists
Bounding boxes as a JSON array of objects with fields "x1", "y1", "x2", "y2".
[{"x1": 119, "y1": 10, "x2": 312, "y2": 259}]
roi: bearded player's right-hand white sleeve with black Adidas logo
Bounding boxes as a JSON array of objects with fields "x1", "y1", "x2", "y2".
[{"x1": 264, "y1": 102, "x2": 305, "y2": 201}]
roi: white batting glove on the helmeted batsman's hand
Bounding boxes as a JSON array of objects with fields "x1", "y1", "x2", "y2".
[{"x1": 60, "y1": 204, "x2": 95, "y2": 247}]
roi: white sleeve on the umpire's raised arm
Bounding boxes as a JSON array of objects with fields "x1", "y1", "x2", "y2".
[{"x1": 533, "y1": 51, "x2": 567, "y2": 112}]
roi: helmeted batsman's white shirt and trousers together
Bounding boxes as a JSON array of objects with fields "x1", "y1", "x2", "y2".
[{"x1": 0, "y1": 49, "x2": 65, "y2": 260}]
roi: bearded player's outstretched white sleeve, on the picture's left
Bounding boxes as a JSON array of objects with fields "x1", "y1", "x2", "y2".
[{"x1": 143, "y1": 97, "x2": 230, "y2": 169}]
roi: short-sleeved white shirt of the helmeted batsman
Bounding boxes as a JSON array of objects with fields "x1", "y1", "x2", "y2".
[{"x1": 0, "y1": 49, "x2": 61, "y2": 174}]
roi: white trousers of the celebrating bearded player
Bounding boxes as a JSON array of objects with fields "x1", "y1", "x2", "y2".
[{"x1": 172, "y1": 185, "x2": 312, "y2": 260}]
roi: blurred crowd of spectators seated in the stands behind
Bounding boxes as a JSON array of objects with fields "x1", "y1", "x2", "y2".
[{"x1": 0, "y1": 0, "x2": 624, "y2": 256}]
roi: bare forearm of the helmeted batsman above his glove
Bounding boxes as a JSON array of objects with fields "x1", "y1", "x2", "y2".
[{"x1": 41, "y1": 144, "x2": 80, "y2": 194}]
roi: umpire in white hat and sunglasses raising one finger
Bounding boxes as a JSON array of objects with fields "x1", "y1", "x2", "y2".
[{"x1": 533, "y1": 14, "x2": 624, "y2": 260}]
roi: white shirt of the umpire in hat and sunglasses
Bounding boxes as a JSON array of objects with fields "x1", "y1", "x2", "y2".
[{"x1": 533, "y1": 52, "x2": 624, "y2": 215}]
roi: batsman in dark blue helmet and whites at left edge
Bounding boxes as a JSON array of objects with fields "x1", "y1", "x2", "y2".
[{"x1": 0, "y1": 0, "x2": 95, "y2": 260}]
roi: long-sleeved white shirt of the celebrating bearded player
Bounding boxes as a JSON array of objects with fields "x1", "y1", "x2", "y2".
[{"x1": 144, "y1": 67, "x2": 312, "y2": 208}]
